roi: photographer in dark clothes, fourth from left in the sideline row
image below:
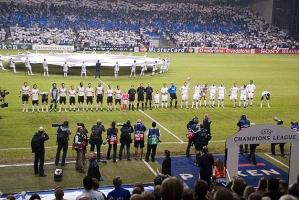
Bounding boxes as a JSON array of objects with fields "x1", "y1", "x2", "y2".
[{"x1": 89, "y1": 120, "x2": 106, "y2": 162}]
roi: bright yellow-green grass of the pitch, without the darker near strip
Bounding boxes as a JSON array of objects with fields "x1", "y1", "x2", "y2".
[{"x1": 0, "y1": 51, "x2": 299, "y2": 194}]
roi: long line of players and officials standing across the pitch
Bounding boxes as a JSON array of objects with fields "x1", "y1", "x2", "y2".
[{"x1": 20, "y1": 79, "x2": 270, "y2": 112}]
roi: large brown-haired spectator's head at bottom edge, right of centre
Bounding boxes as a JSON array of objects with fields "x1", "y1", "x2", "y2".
[{"x1": 161, "y1": 177, "x2": 183, "y2": 200}]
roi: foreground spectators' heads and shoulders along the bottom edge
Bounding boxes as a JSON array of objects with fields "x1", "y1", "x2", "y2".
[{"x1": 7, "y1": 176, "x2": 299, "y2": 200}]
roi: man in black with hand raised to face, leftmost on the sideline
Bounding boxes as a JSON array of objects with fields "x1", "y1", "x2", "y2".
[{"x1": 31, "y1": 127, "x2": 49, "y2": 177}]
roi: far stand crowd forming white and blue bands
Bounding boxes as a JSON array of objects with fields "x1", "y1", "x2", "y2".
[{"x1": 0, "y1": 0, "x2": 299, "y2": 49}]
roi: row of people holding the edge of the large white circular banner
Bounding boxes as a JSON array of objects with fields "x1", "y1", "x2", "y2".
[{"x1": 0, "y1": 57, "x2": 169, "y2": 78}]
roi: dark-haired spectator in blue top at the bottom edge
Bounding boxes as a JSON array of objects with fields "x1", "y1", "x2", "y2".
[{"x1": 107, "y1": 176, "x2": 131, "y2": 200}]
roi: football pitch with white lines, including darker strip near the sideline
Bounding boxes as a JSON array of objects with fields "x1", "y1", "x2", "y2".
[{"x1": 0, "y1": 51, "x2": 299, "y2": 192}]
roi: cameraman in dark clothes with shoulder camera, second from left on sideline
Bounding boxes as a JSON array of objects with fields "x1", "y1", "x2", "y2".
[{"x1": 52, "y1": 121, "x2": 71, "y2": 166}]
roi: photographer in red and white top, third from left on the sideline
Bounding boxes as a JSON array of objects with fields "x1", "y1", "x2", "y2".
[{"x1": 73, "y1": 126, "x2": 86, "y2": 173}]
